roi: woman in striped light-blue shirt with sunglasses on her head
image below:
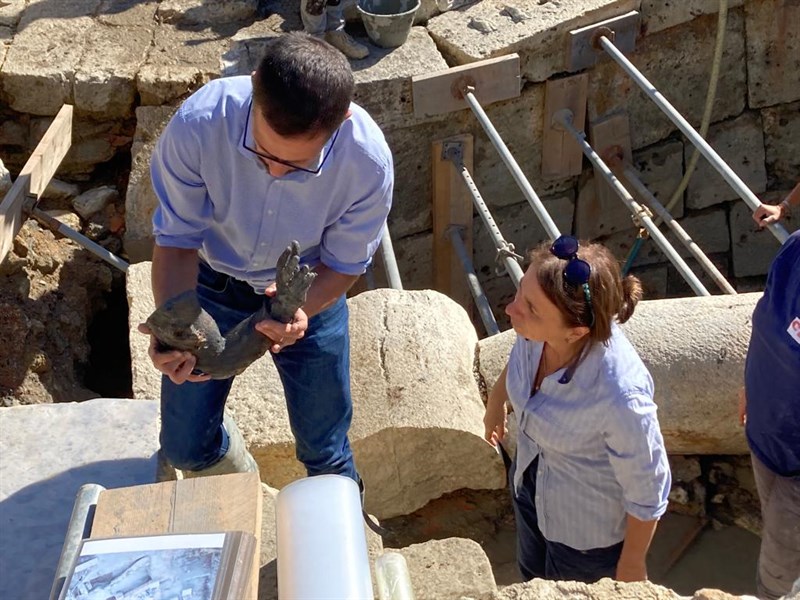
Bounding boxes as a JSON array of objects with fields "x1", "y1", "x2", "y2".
[{"x1": 484, "y1": 236, "x2": 671, "y2": 582}]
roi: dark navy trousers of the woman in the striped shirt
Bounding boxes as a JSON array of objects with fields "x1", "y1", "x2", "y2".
[{"x1": 508, "y1": 458, "x2": 622, "y2": 583}]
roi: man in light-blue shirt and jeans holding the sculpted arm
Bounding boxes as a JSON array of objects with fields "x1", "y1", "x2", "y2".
[{"x1": 140, "y1": 33, "x2": 393, "y2": 489}]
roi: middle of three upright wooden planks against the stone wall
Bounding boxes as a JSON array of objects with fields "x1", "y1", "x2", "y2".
[{"x1": 542, "y1": 73, "x2": 589, "y2": 179}]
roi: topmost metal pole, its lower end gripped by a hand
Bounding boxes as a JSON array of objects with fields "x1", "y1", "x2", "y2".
[{"x1": 597, "y1": 35, "x2": 789, "y2": 244}]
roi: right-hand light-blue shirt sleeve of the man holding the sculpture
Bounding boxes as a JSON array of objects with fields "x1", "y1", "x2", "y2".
[{"x1": 320, "y1": 158, "x2": 394, "y2": 275}]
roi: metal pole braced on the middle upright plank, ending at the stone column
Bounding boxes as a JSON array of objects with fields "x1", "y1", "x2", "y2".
[{"x1": 554, "y1": 110, "x2": 711, "y2": 296}]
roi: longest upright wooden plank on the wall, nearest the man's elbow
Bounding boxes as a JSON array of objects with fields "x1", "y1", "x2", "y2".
[{"x1": 431, "y1": 134, "x2": 473, "y2": 314}]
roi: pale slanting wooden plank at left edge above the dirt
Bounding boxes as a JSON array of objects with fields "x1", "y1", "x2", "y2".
[{"x1": 0, "y1": 104, "x2": 72, "y2": 261}]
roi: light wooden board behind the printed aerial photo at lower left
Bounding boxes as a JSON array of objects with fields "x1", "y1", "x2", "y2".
[{"x1": 89, "y1": 473, "x2": 262, "y2": 600}]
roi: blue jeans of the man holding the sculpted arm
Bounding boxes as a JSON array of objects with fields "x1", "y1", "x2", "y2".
[{"x1": 160, "y1": 262, "x2": 358, "y2": 481}]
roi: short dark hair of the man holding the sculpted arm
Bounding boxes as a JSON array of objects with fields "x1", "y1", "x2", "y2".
[{"x1": 253, "y1": 32, "x2": 355, "y2": 137}]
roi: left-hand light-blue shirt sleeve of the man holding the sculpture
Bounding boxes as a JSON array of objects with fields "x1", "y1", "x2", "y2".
[{"x1": 150, "y1": 110, "x2": 213, "y2": 249}]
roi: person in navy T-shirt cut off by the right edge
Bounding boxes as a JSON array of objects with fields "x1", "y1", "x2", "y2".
[{"x1": 739, "y1": 223, "x2": 800, "y2": 599}]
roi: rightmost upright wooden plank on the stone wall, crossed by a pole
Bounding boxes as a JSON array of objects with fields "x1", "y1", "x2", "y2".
[{"x1": 589, "y1": 113, "x2": 633, "y2": 211}]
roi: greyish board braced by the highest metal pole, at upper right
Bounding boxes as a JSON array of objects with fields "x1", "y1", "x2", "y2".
[{"x1": 565, "y1": 10, "x2": 639, "y2": 71}]
